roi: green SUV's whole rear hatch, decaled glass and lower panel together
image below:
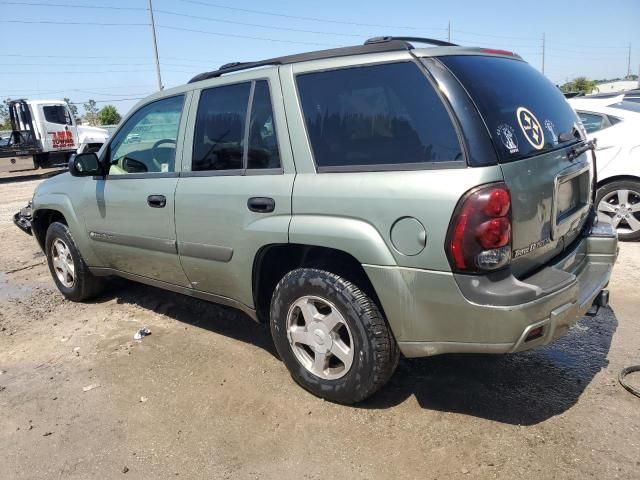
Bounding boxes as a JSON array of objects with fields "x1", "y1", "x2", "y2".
[{"x1": 439, "y1": 55, "x2": 592, "y2": 278}]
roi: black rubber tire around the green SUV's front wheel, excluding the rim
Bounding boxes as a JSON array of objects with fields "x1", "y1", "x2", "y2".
[{"x1": 45, "y1": 222, "x2": 104, "y2": 302}]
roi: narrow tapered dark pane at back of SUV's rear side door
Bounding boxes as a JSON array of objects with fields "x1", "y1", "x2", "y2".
[{"x1": 247, "y1": 80, "x2": 280, "y2": 168}]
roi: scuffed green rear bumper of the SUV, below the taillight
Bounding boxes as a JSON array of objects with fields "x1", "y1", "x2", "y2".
[{"x1": 365, "y1": 225, "x2": 618, "y2": 357}]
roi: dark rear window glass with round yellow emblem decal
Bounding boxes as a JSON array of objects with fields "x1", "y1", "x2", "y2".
[{"x1": 440, "y1": 55, "x2": 579, "y2": 162}]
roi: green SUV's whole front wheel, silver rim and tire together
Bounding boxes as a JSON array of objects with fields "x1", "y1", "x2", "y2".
[{"x1": 45, "y1": 222, "x2": 103, "y2": 302}]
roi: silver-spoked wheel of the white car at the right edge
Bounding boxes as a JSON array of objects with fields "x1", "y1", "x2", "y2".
[{"x1": 596, "y1": 180, "x2": 640, "y2": 241}]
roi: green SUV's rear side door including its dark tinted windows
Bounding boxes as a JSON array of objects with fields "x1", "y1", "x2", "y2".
[{"x1": 176, "y1": 69, "x2": 295, "y2": 307}]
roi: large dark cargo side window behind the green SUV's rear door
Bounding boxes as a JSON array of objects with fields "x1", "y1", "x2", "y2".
[{"x1": 297, "y1": 62, "x2": 462, "y2": 167}]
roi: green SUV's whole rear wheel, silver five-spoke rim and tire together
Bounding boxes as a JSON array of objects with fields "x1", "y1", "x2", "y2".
[{"x1": 271, "y1": 268, "x2": 400, "y2": 404}]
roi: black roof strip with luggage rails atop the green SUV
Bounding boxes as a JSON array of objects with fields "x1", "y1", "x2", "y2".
[{"x1": 189, "y1": 37, "x2": 458, "y2": 83}]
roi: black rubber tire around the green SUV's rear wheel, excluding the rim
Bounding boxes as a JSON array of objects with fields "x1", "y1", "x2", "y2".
[{"x1": 271, "y1": 268, "x2": 400, "y2": 404}]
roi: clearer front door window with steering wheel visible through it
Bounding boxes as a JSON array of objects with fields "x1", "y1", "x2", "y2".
[{"x1": 109, "y1": 96, "x2": 184, "y2": 175}]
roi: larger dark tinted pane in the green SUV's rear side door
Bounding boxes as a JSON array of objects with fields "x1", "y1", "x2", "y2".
[{"x1": 191, "y1": 83, "x2": 251, "y2": 171}]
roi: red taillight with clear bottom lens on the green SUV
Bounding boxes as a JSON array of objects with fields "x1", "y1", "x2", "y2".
[{"x1": 445, "y1": 183, "x2": 511, "y2": 273}]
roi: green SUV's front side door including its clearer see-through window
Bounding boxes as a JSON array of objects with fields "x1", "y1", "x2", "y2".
[{"x1": 84, "y1": 94, "x2": 188, "y2": 286}]
